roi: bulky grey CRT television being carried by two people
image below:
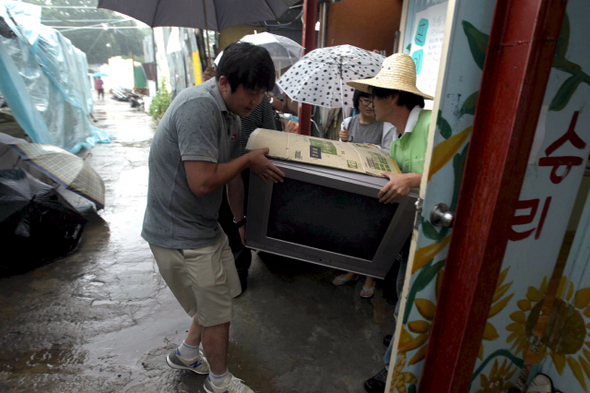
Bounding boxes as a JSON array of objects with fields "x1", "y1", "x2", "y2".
[{"x1": 246, "y1": 160, "x2": 417, "y2": 278}]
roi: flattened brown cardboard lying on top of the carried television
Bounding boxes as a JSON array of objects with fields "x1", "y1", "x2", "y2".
[{"x1": 246, "y1": 128, "x2": 401, "y2": 177}]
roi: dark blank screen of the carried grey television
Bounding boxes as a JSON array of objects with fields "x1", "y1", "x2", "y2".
[{"x1": 267, "y1": 178, "x2": 398, "y2": 260}]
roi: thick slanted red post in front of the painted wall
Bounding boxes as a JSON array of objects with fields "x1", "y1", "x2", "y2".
[{"x1": 418, "y1": 0, "x2": 567, "y2": 393}]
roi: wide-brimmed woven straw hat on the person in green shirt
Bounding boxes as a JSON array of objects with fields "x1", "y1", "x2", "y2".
[{"x1": 346, "y1": 53, "x2": 434, "y2": 100}]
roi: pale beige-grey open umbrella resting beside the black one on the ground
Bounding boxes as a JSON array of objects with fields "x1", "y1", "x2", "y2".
[{"x1": 10, "y1": 143, "x2": 105, "y2": 210}]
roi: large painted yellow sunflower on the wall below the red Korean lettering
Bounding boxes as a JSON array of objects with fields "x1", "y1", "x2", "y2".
[{"x1": 506, "y1": 276, "x2": 590, "y2": 391}]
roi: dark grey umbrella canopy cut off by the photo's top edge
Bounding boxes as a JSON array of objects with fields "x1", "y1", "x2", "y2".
[{"x1": 98, "y1": 0, "x2": 288, "y2": 31}]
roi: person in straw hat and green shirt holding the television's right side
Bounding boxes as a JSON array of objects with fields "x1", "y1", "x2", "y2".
[{"x1": 347, "y1": 53, "x2": 433, "y2": 393}]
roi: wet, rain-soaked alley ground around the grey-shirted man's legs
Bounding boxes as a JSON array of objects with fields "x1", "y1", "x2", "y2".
[{"x1": 0, "y1": 97, "x2": 394, "y2": 393}]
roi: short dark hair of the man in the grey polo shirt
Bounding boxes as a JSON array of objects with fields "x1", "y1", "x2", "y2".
[{"x1": 215, "y1": 42, "x2": 275, "y2": 93}]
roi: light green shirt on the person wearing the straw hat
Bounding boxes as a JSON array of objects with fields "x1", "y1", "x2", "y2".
[{"x1": 389, "y1": 110, "x2": 432, "y2": 173}]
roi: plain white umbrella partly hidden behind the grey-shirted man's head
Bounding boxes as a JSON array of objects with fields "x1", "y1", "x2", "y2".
[{"x1": 215, "y1": 32, "x2": 305, "y2": 70}]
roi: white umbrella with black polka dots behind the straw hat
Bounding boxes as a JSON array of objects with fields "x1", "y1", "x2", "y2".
[{"x1": 277, "y1": 45, "x2": 385, "y2": 108}]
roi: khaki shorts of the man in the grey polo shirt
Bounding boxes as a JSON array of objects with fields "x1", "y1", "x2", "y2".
[{"x1": 150, "y1": 234, "x2": 242, "y2": 326}]
